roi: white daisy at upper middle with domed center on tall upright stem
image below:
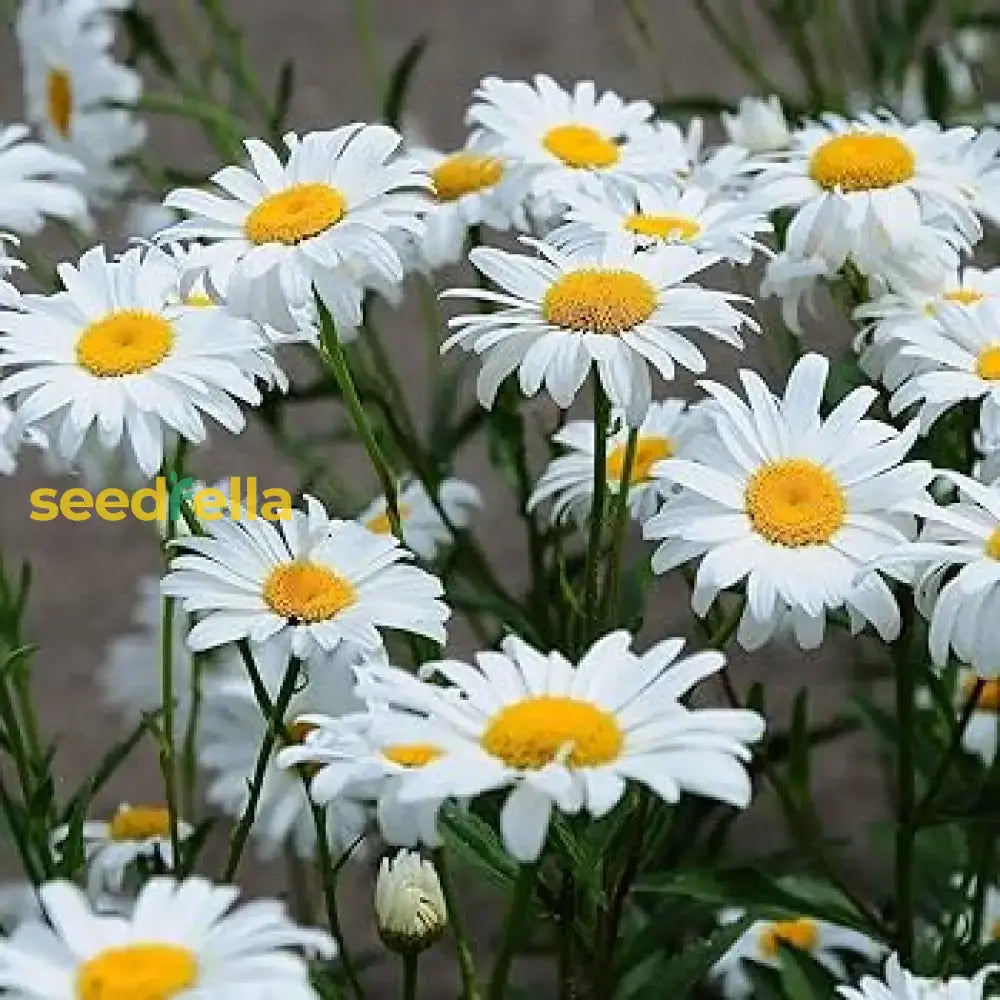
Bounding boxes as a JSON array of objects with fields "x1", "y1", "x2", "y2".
[{"x1": 442, "y1": 237, "x2": 757, "y2": 427}]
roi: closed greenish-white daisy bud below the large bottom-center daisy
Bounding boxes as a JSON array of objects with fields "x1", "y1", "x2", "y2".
[{"x1": 375, "y1": 851, "x2": 448, "y2": 954}]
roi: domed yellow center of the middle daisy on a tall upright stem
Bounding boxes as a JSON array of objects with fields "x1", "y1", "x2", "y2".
[{"x1": 542, "y1": 267, "x2": 656, "y2": 334}]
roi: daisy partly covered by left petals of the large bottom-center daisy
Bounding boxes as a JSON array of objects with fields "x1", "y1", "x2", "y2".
[{"x1": 278, "y1": 708, "x2": 464, "y2": 848}]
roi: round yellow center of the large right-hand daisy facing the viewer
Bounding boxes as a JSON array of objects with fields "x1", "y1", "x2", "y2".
[{"x1": 745, "y1": 458, "x2": 847, "y2": 548}]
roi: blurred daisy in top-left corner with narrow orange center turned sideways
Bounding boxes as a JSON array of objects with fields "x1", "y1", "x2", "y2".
[{"x1": 17, "y1": 0, "x2": 146, "y2": 206}]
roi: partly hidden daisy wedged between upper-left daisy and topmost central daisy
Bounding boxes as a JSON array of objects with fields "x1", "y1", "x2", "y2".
[{"x1": 409, "y1": 135, "x2": 530, "y2": 271}]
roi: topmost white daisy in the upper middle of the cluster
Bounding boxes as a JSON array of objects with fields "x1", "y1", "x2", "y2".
[{"x1": 466, "y1": 73, "x2": 663, "y2": 216}]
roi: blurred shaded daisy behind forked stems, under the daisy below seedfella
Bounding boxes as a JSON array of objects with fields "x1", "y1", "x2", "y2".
[{"x1": 198, "y1": 643, "x2": 365, "y2": 859}]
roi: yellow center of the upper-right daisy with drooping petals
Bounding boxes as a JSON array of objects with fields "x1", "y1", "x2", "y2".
[{"x1": 809, "y1": 132, "x2": 916, "y2": 191}]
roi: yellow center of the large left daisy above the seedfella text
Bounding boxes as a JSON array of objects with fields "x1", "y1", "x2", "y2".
[{"x1": 76, "y1": 309, "x2": 174, "y2": 378}]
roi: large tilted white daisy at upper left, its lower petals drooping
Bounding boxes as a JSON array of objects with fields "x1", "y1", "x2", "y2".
[{"x1": 159, "y1": 124, "x2": 430, "y2": 334}]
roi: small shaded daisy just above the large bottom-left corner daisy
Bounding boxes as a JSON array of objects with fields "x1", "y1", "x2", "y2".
[{"x1": 52, "y1": 803, "x2": 194, "y2": 899}]
